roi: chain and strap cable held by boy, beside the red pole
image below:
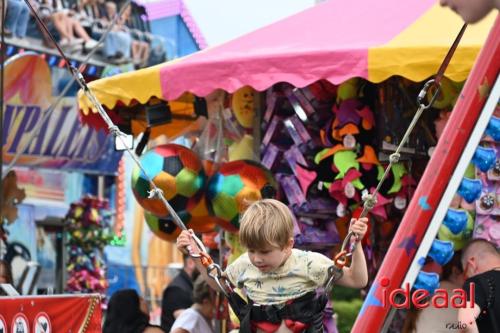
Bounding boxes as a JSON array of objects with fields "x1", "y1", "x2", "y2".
[{"x1": 325, "y1": 24, "x2": 467, "y2": 290}]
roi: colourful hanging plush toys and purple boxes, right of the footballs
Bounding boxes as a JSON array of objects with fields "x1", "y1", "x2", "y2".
[{"x1": 261, "y1": 78, "x2": 464, "y2": 298}]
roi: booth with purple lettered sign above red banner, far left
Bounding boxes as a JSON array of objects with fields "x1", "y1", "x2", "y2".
[{"x1": 0, "y1": 51, "x2": 126, "y2": 332}]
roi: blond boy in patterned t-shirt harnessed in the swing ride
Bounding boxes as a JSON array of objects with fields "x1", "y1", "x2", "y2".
[{"x1": 177, "y1": 199, "x2": 368, "y2": 333}]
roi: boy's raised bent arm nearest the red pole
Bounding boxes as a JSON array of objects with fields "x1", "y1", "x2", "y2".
[{"x1": 337, "y1": 217, "x2": 368, "y2": 288}]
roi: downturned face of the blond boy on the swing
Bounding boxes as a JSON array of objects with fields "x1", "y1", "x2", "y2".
[{"x1": 248, "y1": 239, "x2": 293, "y2": 273}]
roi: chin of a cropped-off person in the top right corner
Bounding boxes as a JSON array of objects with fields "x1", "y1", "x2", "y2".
[{"x1": 439, "y1": 0, "x2": 500, "y2": 23}]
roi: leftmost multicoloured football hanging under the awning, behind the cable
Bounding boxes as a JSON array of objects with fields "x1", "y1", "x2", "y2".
[{"x1": 132, "y1": 144, "x2": 205, "y2": 218}]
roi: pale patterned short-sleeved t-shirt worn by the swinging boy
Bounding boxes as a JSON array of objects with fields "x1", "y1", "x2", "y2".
[{"x1": 226, "y1": 249, "x2": 333, "y2": 304}]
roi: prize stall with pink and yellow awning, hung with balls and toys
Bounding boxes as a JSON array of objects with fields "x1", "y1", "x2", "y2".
[{"x1": 79, "y1": 0, "x2": 499, "y2": 331}]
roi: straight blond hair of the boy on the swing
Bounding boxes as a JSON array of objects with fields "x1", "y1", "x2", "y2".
[{"x1": 240, "y1": 199, "x2": 293, "y2": 249}]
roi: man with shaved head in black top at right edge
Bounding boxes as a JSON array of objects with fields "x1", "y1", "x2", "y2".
[{"x1": 458, "y1": 239, "x2": 500, "y2": 333}]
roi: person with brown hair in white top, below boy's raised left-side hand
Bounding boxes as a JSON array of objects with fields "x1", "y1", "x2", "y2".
[{"x1": 170, "y1": 276, "x2": 215, "y2": 333}]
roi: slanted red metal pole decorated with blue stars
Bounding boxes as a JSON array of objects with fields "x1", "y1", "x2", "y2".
[{"x1": 351, "y1": 17, "x2": 500, "y2": 333}]
